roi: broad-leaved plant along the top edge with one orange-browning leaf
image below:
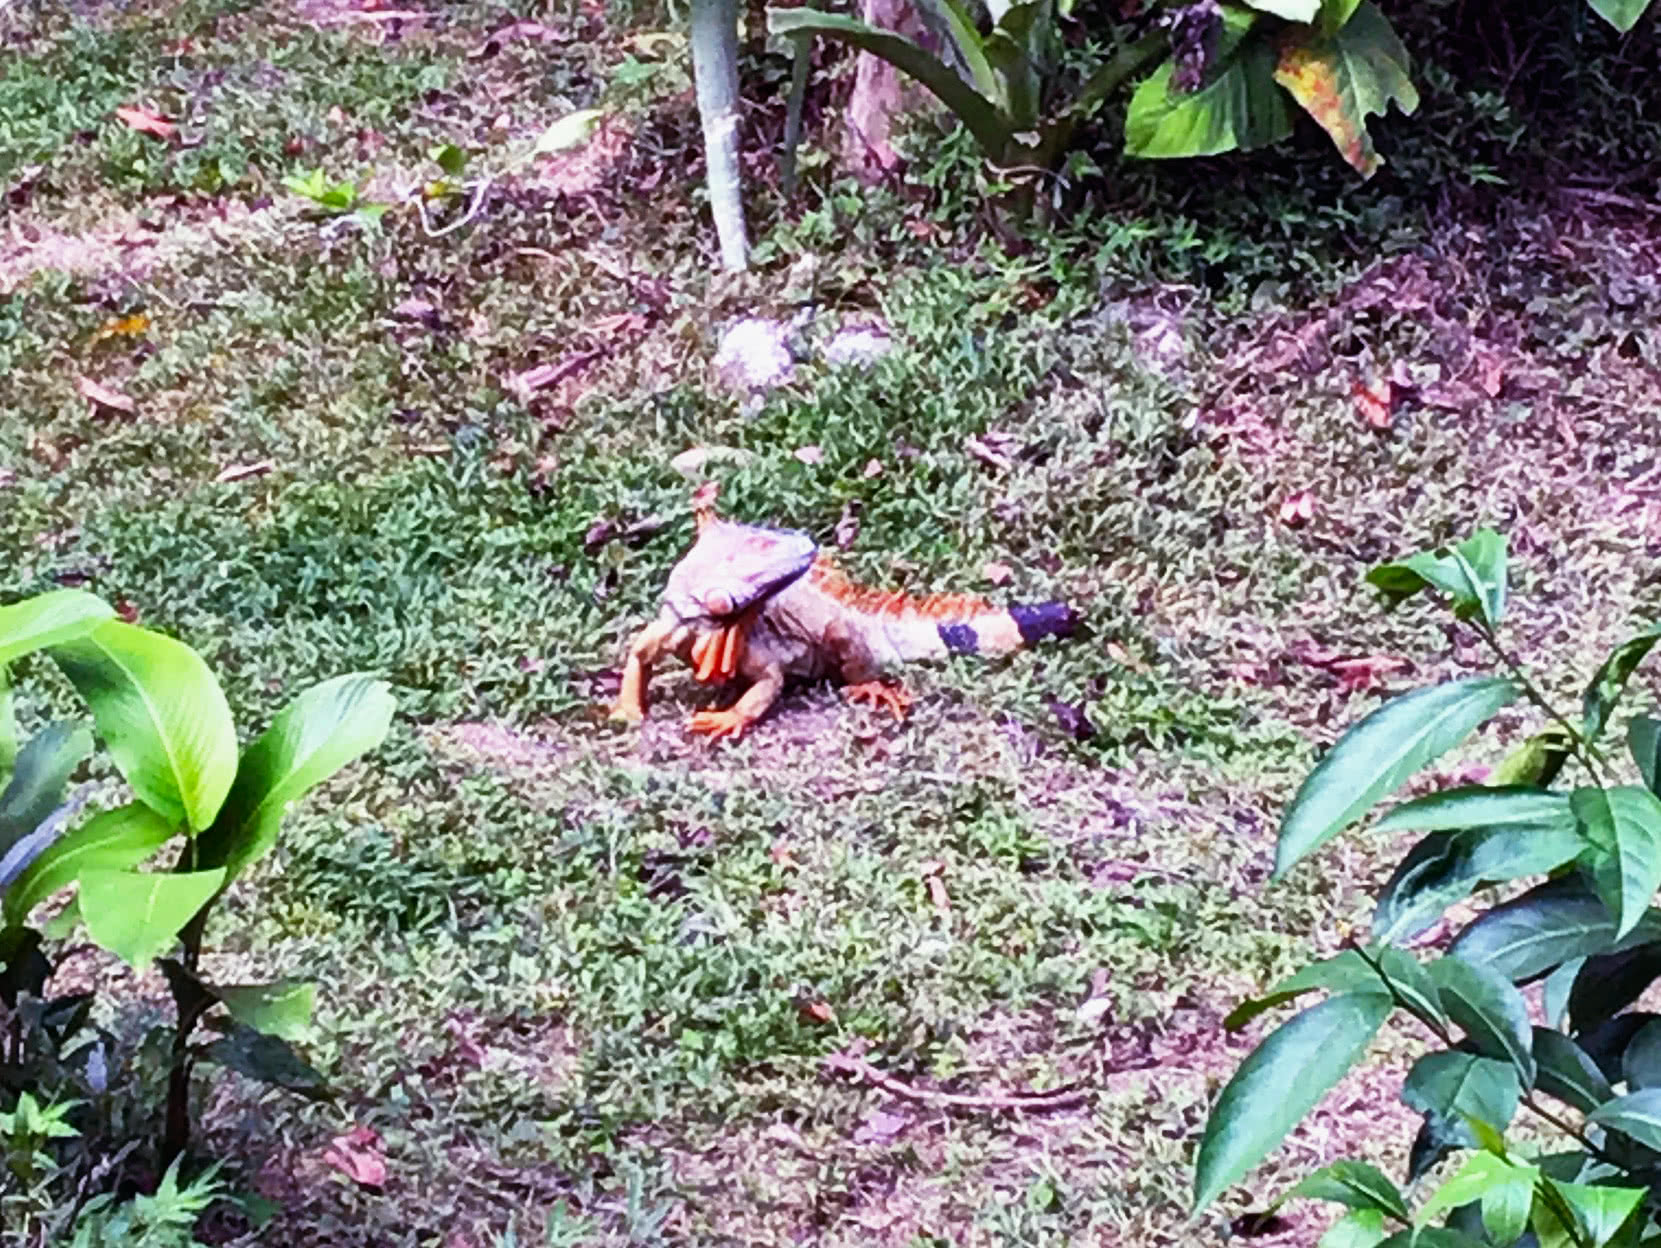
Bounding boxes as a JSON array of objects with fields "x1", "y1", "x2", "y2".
[{"x1": 767, "y1": 0, "x2": 1649, "y2": 197}]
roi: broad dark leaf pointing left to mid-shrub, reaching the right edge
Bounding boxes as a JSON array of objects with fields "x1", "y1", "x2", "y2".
[{"x1": 1448, "y1": 879, "x2": 1661, "y2": 984}]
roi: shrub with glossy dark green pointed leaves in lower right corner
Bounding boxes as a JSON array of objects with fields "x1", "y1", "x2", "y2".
[{"x1": 1194, "y1": 530, "x2": 1661, "y2": 1248}]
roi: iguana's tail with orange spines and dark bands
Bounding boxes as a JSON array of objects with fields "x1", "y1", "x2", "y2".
[{"x1": 809, "y1": 557, "x2": 1078, "y2": 663}]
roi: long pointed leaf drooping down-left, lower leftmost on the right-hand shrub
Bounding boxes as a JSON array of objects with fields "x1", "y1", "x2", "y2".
[{"x1": 1194, "y1": 992, "x2": 1394, "y2": 1210}]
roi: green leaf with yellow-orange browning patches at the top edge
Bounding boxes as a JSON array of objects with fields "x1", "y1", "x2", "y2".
[{"x1": 1274, "y1": 0, "x2": 1415, "y2": 177}]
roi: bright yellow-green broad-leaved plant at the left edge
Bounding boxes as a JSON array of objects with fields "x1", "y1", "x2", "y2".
[{"x1": 0, "y1": 590, "x2": 394, "y2": 1165}]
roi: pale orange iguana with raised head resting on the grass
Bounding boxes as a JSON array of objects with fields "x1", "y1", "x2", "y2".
[{"x1": 611, "y1": 482, "x2": 1078, "y2": 738}]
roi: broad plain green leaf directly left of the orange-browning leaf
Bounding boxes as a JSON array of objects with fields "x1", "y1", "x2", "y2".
[{"x1": 1124, "y1": 3, "x2": 1292, "y2": 158}]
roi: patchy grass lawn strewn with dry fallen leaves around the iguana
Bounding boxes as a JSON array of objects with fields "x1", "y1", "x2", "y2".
[{"x1": 0, "y1": 0, "x2": 1661, "y2": 1245}]
